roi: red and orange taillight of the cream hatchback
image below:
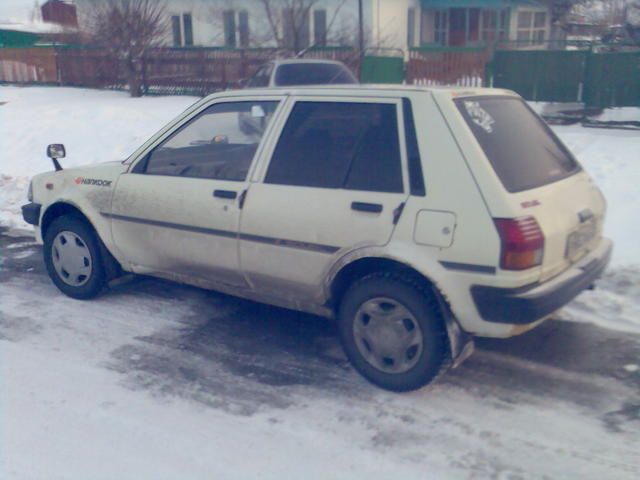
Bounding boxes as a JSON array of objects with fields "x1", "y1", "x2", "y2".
[{"x1": 493, "y1": 216, "x2": 544, "y2": 270}]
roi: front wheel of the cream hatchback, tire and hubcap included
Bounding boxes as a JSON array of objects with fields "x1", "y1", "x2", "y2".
[{"x1": 43, "y1": 215, "x2": 106, "y2": 300}]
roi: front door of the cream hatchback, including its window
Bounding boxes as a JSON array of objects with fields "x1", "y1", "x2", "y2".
[{"x1": 107, "y1": 97, "x2": 280, "y2": 286}]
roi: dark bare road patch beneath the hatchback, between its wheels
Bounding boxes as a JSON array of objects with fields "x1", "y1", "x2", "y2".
[{"x1": 108, "y1": 278, "x2": 369, "y2": 415}]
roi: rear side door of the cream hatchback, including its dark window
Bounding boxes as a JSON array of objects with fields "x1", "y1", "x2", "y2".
[{"x1": 240, "y1": 97, "x2": 408, "y2": 300}]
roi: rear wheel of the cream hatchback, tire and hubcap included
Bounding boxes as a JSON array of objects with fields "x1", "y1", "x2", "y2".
[{"x1": 338, "y1": 272, "x2": 449, "y2": 392}]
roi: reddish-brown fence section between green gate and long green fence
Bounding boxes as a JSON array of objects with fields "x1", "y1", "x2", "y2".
[{"x1": 406, "y1": 47, "x2": 491, "y2": 87}]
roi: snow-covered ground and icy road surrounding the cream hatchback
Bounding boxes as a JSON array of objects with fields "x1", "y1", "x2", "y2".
[{"x1": 0, "y1": 86, "x2": 640, "y2": 480}]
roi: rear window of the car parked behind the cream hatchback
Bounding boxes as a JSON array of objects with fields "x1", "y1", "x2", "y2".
[{"x1": 275, "y1": 63, "x2": 358, "y2": 86}]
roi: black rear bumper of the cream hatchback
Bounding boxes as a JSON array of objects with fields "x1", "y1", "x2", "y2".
[{"x1": 471, "y1": 239, "x2": 613, "y2": 325}]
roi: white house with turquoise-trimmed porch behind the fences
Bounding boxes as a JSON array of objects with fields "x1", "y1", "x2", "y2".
[{"x1": 74, "y1": 0, "x2": 552, "y2": 53}]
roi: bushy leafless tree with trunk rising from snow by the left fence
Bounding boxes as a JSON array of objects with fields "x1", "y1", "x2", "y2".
[{"x1": 88, "y1": 0, "x2": 168, "y2": 97}]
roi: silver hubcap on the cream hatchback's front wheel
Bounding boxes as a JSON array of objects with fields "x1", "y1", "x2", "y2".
[{"x1": 51, "y1": 231, "x2": 91, "y2": 287}]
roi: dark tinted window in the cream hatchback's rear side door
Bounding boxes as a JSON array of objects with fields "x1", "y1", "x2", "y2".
[{"x1": 265, "y1": 102, "x2": 403, "y2": 192}]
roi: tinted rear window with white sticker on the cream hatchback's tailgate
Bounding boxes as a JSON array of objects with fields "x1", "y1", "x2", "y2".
[{"x1": 455, "y1": 96, "x2": 580, "y2": 192}]
